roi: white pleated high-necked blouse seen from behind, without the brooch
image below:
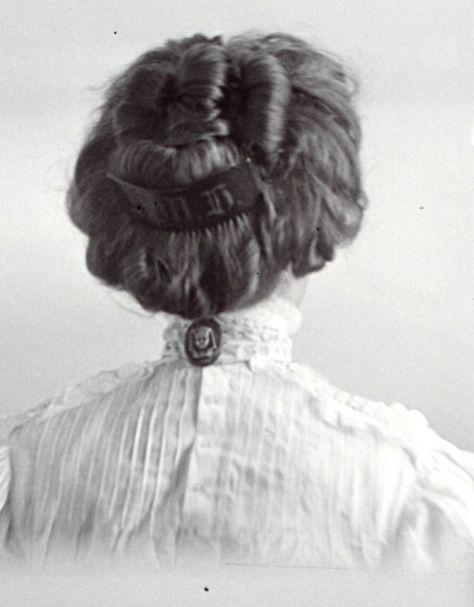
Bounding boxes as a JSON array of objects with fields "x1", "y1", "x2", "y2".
[{"x1": 0, "y1": 298, "x2": 474, "y2": 568}]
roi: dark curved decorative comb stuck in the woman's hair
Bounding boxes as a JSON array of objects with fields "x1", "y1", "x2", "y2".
[{"x1": 107, "y1": 157, "x2": 265, "y2": 232}]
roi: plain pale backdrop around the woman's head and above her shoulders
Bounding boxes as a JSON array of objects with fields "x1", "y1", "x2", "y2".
[{"x1": 0, "y1": 0, "x2": 474, "y2": 450}]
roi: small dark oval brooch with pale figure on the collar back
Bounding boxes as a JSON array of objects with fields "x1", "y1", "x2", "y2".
[{"x1": 185, "y1": 318, "x2": 222, "y2": 367}]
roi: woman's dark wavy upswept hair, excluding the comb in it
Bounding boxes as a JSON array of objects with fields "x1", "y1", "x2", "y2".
[{"x1": 67, "y1": 34, "x2": 366, "y2": 319}]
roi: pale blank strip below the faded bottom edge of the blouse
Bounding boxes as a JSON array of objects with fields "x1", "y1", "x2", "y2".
[{"x1": 0, "y1": 567, "x2": 474, "y2": 607}]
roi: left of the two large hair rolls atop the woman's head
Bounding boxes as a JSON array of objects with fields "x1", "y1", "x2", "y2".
[{"x1": 114, "y1": 38, "x2": 229, "y2": 147}]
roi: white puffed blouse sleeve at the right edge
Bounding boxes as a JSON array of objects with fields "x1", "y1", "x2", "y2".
[{"x1": 386, "y1": 431, "x2": 474, "y2": 570}]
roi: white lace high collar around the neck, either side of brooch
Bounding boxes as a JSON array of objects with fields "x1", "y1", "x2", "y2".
[{"x1": 163, "y1": 295, "x2": 302, "y2": 367}]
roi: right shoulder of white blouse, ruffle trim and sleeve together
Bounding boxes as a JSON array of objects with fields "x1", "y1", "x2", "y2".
[{"x1": 286, "y1": 365, "x2": 474, "y2": 570}]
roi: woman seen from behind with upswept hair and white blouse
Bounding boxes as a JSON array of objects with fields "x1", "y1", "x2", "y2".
[{"x1": 0, "y1": 34, "x2": 474, "y2": 568}]
